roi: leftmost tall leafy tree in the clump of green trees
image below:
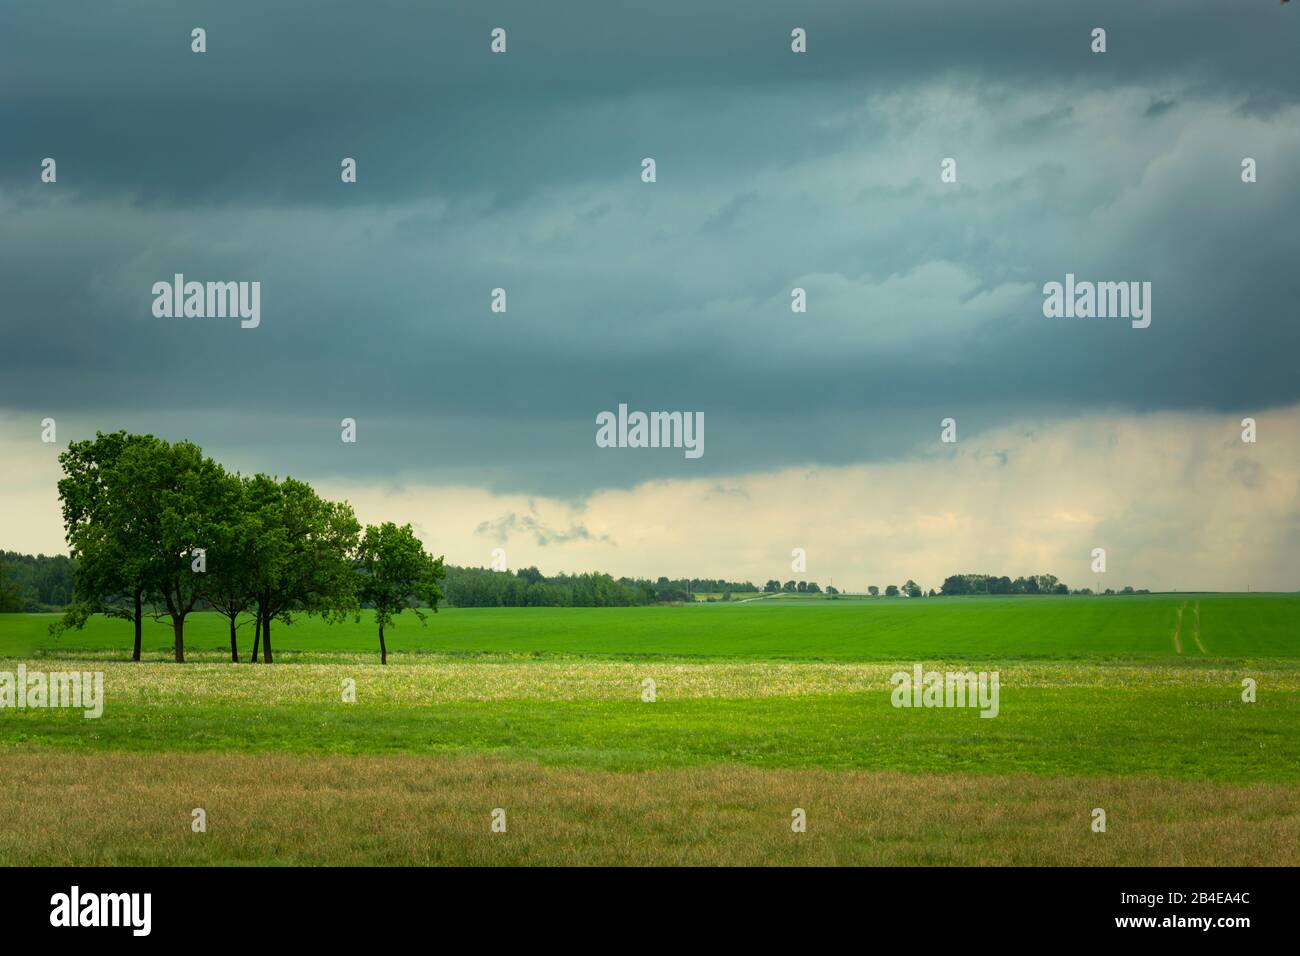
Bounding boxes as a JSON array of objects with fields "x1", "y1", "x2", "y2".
[{"x1": 49, "y1": 432, "x2": 164, "y2": 661}]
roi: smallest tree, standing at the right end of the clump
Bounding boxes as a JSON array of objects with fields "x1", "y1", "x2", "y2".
[{"x1": 356, "y1": 522, "x2": 446, "y2": 665}]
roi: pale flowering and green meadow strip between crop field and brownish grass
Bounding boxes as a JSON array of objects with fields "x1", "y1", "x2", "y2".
[{"x1": 0, "y1": 656, "x2": 1300, "y2": 782}]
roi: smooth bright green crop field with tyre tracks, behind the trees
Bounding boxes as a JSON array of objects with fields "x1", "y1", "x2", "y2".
[{"x1": 0, "y1": 594, "x2": 1300, "y2": 661}]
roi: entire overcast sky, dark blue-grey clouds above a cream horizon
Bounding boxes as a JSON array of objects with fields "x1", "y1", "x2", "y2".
[{"x1": 0, "y1": 0, "x2": 1300, "y2": 591}]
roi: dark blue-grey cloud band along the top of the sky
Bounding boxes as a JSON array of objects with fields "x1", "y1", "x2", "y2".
[{"x1": 0, "y1": 0, "x2": 1300, "y2": 208}]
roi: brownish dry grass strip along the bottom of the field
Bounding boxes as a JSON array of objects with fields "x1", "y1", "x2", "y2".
[{"x1": 0, "y1": 753, "x2": 1300, "y2": 866}]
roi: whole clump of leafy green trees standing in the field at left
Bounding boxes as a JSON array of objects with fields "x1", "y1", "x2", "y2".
[{"x1": 52, "y1": 432, "x2": 445, "y2": 663}]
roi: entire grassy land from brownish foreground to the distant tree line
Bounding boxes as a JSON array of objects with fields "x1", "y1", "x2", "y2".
[{"x1": 0, "y1": 594, "x2": 1300, "y2": 865}]
